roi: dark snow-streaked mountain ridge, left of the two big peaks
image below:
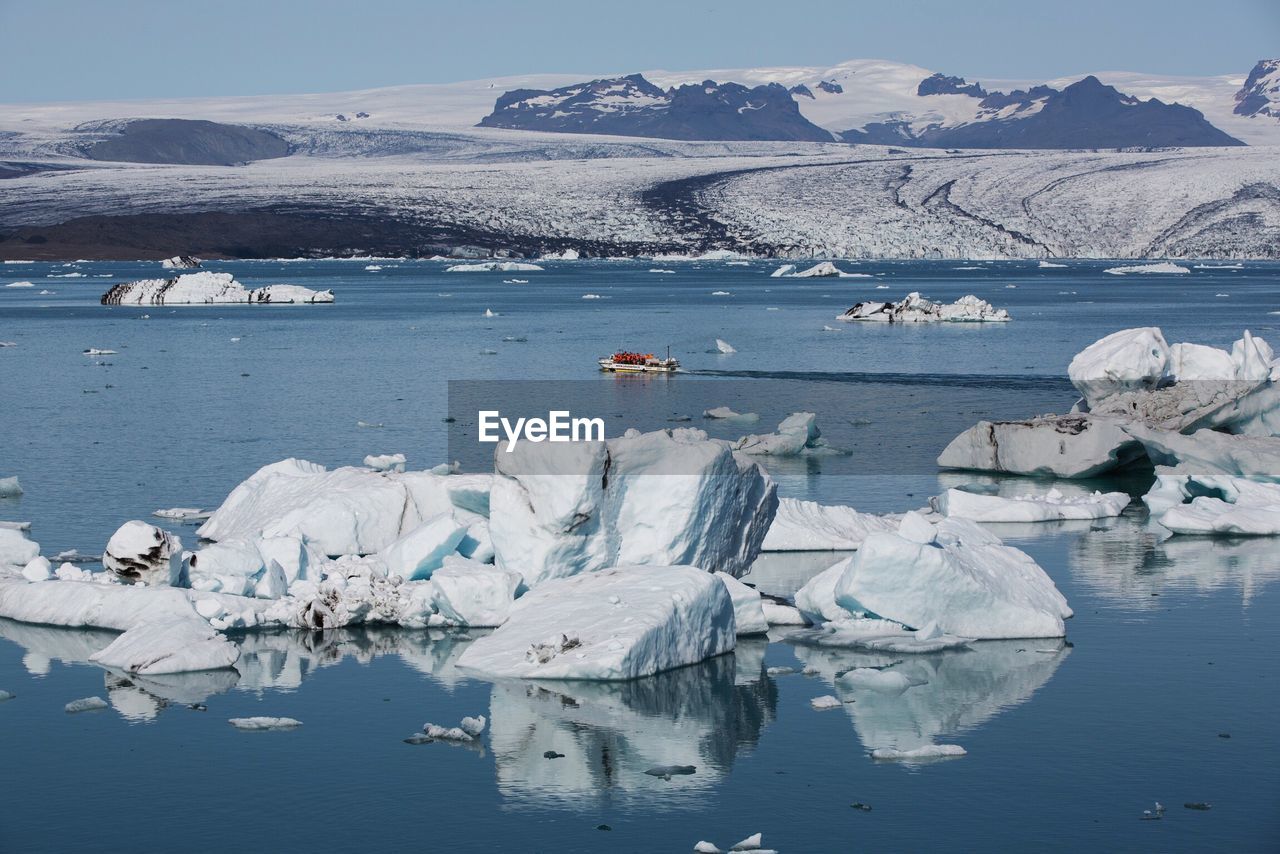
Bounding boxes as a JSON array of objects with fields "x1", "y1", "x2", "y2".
[{"x1": 480, "y1": 74, "x2": 832, "y2": 142}]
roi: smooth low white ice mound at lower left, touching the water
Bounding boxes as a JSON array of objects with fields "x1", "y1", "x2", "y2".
[{"x1": 90, "y1": 616, "x2": 239, "y2": 676}]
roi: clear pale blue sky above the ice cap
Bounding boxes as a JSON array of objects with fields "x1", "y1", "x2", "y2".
[{"x1": 0, "y1": 0, "x2": 1280, "y2": 102}]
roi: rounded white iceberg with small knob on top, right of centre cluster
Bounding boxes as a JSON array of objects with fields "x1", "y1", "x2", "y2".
[{"x1": 829, "y1": 513, "x2": 1071, "y2": 639}]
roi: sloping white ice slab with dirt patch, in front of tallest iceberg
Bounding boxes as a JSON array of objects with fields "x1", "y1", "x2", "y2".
[{"x1": 458, "y1": 566, "x2": 735, "y2": 680}]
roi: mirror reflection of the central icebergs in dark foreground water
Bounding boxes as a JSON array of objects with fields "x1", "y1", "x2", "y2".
[{"x1": 489, "y1": 640, "x2": 777, "y2": 809}]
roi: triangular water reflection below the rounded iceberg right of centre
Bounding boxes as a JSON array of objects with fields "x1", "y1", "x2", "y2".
[{"x1": 796, "y1": 639, "x2": 1071, "y2": 762}]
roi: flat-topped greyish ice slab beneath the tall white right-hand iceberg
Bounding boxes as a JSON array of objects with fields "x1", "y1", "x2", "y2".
[{"x1": 938, "y1": 415, "x2": 1143, "y2": 478}]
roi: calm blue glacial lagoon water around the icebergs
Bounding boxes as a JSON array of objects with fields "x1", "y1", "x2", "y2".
[{"x1": 0, "y1": 261, "x2": 1280, "y2": 851}]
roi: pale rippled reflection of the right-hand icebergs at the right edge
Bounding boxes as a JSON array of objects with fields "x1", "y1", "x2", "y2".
[{"x1": 1068, "y1": 517, "x2": 1280, "y2": 611}]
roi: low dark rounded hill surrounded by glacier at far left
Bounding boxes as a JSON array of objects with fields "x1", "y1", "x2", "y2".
[{"x1": 83, "y1": 119, "x2": 291, "y2": 166}]
